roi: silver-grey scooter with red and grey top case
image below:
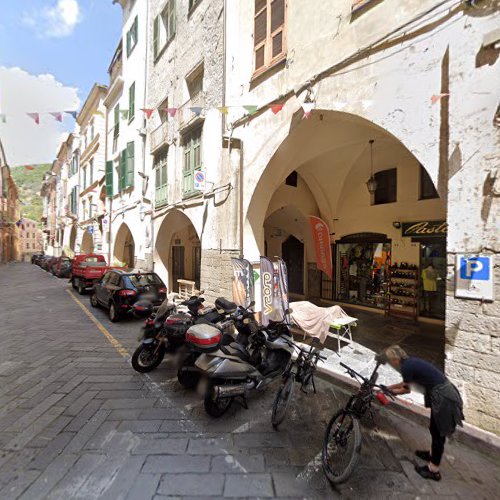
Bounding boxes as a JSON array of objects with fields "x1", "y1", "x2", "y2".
[{"x1": 186, "y1": 316, "x2": 293, "y2": 417}]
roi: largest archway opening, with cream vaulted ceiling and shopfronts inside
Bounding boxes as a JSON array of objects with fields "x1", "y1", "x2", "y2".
[{"x1": 245, "y1": 110, "x2": 446, "y2": 361}]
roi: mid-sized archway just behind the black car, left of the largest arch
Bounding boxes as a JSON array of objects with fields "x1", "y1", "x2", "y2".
[{"x1": 155, "y1": 210, "x2": 201, "y2": 292}]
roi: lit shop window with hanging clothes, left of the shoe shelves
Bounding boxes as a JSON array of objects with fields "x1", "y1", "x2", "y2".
[{"x1": 336, "y1": 241, "x2": 391, "y2": 309}]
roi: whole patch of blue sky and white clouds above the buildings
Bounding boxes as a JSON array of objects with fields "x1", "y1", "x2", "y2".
[{"x1": 0, "y1": 0, "x2": 123, "y2": 166}]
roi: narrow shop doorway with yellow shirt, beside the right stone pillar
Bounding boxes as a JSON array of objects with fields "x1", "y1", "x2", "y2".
[{"x1": 419, "y1": 238, "x2": 446, "y2": 320}]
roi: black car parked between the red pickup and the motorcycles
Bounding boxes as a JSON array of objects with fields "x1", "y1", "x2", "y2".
[{"x1": 90, "y1": 269, "x2": 167, "y2": 322}]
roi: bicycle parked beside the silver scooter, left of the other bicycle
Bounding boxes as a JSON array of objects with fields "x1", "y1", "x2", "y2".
[{"x1": 271, "y1": 340, "x2": 326, "y2": 430}]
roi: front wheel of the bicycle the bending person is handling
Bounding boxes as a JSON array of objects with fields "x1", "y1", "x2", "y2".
[{"x1": 322, "y1": 410, "x2": 361, "y2": 484}]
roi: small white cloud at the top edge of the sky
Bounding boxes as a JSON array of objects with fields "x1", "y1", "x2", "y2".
[{"x1": 23, "y1": 0, "x2": 82, "y2": 38}]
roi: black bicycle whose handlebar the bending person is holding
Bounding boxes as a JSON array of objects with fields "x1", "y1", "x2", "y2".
[{"x1": 321, "y1": 361, "x2": 395, "y2": 484}]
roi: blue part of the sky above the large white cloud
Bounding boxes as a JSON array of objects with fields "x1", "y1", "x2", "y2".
[{"x1": 0, "y1": 0, "x2": 121, "y2": 100}]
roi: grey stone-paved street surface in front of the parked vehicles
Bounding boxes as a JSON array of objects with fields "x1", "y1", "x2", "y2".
[{"x1": 0, "y1": 264, "x2": 500, "y2": 500}]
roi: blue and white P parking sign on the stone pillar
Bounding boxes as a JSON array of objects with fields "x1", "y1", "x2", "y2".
[{"x1": 455, "y1": 254, "x2": 493, "y2": 300}]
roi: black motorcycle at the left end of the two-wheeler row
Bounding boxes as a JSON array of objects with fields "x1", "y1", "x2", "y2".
[{"x1": 132, "y1": 291, "x2": 236, "y2": 378}]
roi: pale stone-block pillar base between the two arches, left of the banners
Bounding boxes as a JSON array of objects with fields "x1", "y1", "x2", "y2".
[{"x1": 201, "y1": 249, "x2": 239, "y2": 302}]
